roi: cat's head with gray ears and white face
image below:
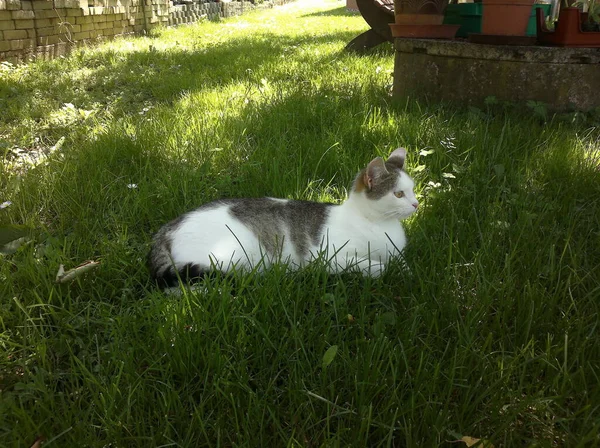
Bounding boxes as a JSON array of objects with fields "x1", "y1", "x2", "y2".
[{"x1": 352, "y1": 148, "x2": 419, "y2": 219}]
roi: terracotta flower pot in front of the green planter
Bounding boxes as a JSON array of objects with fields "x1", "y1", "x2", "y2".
[{"x1": 481, "y1": 0, "x2": 534, "y2": 36}]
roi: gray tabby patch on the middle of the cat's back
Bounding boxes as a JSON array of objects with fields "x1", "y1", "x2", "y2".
[{"x1": 228, "y1": 198, "x2": 333, "y2": 257}]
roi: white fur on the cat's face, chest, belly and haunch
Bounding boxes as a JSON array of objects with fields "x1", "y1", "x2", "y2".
[{"x1": 166, "y1": 168, "x2": 418, "y2": 277}]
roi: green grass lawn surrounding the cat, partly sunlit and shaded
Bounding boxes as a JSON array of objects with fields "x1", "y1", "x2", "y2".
[{"x1": 0, "y1": 0, "x2": 600, "y2": 447}]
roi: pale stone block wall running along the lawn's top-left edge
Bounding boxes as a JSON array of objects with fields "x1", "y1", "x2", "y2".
[{"x1": 0, "y1": 0, "x2": 287, "y2": 63}]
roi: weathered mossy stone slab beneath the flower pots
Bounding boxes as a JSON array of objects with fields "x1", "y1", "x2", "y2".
[{"x1": 393, "y1": 39, "x2": 600, "y2": 111}]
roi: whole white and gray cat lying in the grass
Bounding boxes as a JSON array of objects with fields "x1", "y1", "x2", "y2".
[{"x1": 148, "y1": 148, "x2": 419, "y2": 287}]
